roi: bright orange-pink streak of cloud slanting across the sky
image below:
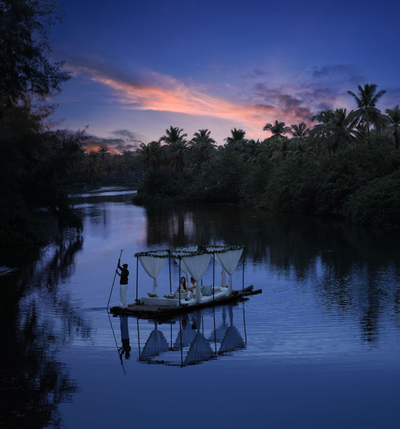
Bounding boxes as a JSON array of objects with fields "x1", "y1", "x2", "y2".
[{"x1": 70, "y1": 66, "x2": 316, "y2": 138}]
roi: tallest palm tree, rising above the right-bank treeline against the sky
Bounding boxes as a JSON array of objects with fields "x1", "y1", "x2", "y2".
[{"x1": 347, "y1": 84, "x2": 386, "y2": 136}]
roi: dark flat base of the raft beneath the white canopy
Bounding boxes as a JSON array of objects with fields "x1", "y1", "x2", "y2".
[{"x1": 110, "y1": 285, "x2": 262, "y2": 319}]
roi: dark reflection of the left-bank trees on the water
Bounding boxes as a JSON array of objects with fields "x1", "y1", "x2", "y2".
[{"x1": 0, "y1": 236, "x2": 91, "y2": 428}]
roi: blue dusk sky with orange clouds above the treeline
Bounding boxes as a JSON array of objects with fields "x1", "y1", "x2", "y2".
[{"x1": 50, "y1": 0, "x2": 400, "y2": 153}]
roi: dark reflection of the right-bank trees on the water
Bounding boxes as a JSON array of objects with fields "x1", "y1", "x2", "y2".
[{"x1": 141, "y1": 205, "x2": 400, "y2": 341}]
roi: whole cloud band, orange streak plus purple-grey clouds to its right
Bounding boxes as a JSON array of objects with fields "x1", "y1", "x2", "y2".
[{"x1": 67, "y1": 56, "x2": 386, "y2": 139}]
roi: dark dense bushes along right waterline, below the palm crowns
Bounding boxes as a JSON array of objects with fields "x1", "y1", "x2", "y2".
[{"x1": 133, "y1": 140, "x2": 400, "y2": 229}]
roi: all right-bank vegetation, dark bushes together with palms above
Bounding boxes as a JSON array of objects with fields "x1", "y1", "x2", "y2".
[{"x1": 134, "y1": 85, "x2": 400, "y2": 227}]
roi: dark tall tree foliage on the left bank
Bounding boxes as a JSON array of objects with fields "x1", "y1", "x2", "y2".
[{"x1": 0, "y1": 0, "x2": 82, "y2": 246}]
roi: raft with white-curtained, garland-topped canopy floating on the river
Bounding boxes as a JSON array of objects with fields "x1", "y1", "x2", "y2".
[{"x1": 110, "y1": 245, "x2": 262, "y2": 317}]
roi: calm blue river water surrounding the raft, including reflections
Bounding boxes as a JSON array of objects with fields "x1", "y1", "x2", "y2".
[{"x1": 0, "y1": 190, "x2": 400, "y2": 429}]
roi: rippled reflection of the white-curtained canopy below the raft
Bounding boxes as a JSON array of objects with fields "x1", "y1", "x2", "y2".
[{"x1": 128, "y1": 304, "x2": 246, "y2": 367}]
